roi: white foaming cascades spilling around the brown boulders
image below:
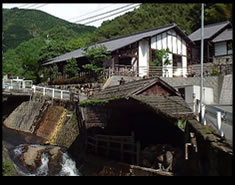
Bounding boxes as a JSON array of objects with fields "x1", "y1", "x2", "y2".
[{"x1": 13, "y1": 144, "x2": 81, "y2": 176}]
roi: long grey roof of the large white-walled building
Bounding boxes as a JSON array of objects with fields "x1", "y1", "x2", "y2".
[{"x1": 43, "y1": 23, "x2": 193, "y2": 65}]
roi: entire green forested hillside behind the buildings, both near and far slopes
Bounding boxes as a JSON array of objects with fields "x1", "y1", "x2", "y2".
[{"x1": 3, "y1": 3, "x2": 232, "y2": 83}]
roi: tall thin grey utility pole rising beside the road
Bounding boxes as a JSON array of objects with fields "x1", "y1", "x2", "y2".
[{"x1": 200, "y1": 3, "x2": 204, "y2": 123}]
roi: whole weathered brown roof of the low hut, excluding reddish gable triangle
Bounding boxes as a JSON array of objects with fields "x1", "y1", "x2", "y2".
[{"x1": 88, "y1": 78, "x2": 193, "y2": 118}]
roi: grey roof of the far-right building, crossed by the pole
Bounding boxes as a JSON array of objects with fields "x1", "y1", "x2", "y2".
[{"x1": 189, "y1": 21, "x2": 231, "y2": 41}]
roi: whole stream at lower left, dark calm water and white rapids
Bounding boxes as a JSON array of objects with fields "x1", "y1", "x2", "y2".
[{"x1": 3, "y1": 127, "x2": 81, "y2": 176}]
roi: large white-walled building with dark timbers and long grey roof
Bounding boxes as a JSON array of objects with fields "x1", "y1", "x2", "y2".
[{"x1": 43, "y1": 23, "x2": 194, "y2": 77}]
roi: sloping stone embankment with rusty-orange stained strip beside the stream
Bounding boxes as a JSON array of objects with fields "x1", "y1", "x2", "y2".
[{"x1": 3, "y1": 94, "x2": 79, "y2": 148}]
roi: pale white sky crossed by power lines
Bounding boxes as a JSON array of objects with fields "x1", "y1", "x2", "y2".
[{"x1": 2, "y1": 3, "x2": 140, "y2": 27}]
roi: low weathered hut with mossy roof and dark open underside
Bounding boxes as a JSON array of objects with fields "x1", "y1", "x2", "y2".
[{"x1": 81, "y1": 78, "x2": 193, "y2": 146}]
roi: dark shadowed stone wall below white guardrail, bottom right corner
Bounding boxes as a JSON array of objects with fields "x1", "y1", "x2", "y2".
[{"x1": 186, "y1": 120, "x2": 233, "y2": 176}]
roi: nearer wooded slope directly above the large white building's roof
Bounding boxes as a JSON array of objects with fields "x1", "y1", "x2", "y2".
[{"x1": 93, "y1": 3, "x2": 232, "y2": 41}]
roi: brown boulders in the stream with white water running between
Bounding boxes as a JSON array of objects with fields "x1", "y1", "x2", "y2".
[{"x1": 14, "y1": 144, "x2": 79, "y2": 176}]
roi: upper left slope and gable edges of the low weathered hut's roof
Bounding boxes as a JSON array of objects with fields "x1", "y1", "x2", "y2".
[{"x1": 92, "y1": 77, "x2": 180, "y2": 100}]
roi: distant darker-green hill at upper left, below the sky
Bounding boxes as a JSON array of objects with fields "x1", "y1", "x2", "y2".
[{"x1": 2, "y1": 8, "x2": 95, "y2": 52}]
